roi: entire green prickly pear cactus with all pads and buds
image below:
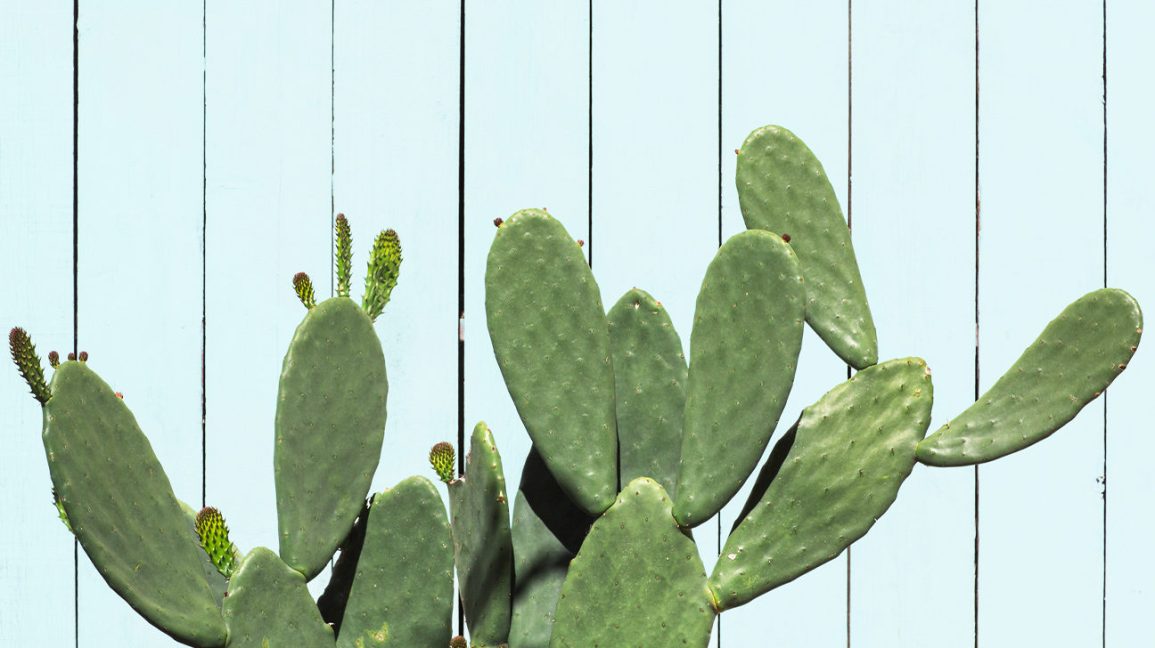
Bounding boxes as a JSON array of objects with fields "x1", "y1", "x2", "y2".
[{"x1": 9, "y1": 126, "x2": 1142, "y2": 648}]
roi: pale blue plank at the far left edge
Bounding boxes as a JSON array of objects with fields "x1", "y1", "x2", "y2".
[{"x1": 0, "y1": 3, "x2": 75, "y2": 646}]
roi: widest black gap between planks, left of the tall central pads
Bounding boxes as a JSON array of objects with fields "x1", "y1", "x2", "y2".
[{"x1": 457, "y1": 0, "x2": 465, "y2": 635}]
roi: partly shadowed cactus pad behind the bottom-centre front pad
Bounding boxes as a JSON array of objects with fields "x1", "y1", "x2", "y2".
[{"x1": 509, "y1": 448, "x2": 594, "y2": 648}]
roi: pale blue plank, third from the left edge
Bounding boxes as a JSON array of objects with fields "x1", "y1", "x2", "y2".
[{"x1": 206, "y1": 0, "x2": 332, "y2": 590}]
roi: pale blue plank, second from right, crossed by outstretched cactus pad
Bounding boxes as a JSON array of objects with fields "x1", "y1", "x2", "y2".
[{"x1": 978, "y1": 2, "x2": 1103, "y2": 648}]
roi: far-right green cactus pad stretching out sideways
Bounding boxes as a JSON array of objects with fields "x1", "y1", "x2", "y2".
[{"x1": 918, "y1": 289, "x2": 1143, "y2": 465}]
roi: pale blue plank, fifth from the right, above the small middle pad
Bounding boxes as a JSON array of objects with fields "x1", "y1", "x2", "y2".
[{"x1": 593, "y1": 1, "x2": 718, "y2": 641}]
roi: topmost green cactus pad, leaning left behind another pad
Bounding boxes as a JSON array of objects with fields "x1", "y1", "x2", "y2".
[{"x1": 736, "y1": 126, "x2": 878, "y2": 368}]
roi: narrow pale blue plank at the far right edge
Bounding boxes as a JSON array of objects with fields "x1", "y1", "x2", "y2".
[{"x1": 1106, "y1": 2, "x2": 1155, "y2": 646}]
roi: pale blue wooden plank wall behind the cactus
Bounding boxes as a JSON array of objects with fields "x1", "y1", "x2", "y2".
[{"x1": 0, "y1": 0, "x2": 1155, "y2": 648}]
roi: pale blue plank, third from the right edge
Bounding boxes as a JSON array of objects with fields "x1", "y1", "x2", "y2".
[{"x1": 850, "y1": 2, "x2": 975, "y2": 647}]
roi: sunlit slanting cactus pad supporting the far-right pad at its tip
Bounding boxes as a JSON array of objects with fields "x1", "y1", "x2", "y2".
[{"x1": 710, "y1": 358, "x2": 933, "y2": 610}]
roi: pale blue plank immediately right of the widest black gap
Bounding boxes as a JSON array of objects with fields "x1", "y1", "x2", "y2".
[{"x1": 462, "y1": 1, "x2": 586, "y2": 549}]
